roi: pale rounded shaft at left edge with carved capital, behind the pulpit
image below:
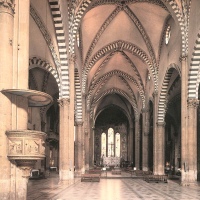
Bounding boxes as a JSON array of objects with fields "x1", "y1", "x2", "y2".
[{"x1": 0, "y1": 1, "x2": 15, "y2": 199}]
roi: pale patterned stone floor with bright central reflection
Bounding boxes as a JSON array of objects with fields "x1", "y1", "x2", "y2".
[{"x1": 27, "y1": 172, "x2": 200, "y2": 200}]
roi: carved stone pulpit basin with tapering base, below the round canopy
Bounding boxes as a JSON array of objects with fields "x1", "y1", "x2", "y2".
[{"x1": 6, "y1": 130, "x2": 46, "y2": 177}]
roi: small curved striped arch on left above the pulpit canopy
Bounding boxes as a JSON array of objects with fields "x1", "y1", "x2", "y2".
[{"x1": 29, "y1": 57, "x2": 61, "y2": 94}]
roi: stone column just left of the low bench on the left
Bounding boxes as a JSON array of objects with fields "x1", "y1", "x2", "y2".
[{"x1": 75, "y1": 122, "x2": 84, "y2": 174}]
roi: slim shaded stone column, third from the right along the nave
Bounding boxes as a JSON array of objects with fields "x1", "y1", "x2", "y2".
[{"x1": 142, "y1": 109, "x2": 149, "y2": 171}]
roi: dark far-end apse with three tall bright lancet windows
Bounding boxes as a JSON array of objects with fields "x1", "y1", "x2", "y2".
[{"x1": 94, "y1": 105, "x2": 129, "y2": 166}]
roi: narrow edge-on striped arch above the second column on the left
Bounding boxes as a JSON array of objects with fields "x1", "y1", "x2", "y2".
[{"x1": 74, "y1": 69, "x2": 83, "y2": 122}]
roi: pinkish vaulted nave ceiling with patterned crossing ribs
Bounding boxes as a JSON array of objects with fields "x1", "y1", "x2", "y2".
[{"x1": 79, "y1": 0, "x2": 170, "y2": 121}]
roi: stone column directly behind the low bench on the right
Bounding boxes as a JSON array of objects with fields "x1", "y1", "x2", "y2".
[{"x1": 154, "y1": 122, "x2": 165, "y2": 175}]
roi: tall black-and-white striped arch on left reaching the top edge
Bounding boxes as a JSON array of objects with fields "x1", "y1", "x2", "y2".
[{"x1": 49, "y1": 0, "x2": 70, "y2": 98}]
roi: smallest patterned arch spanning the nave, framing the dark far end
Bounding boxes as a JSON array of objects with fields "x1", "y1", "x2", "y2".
[{"x1": 90, "y1": 88, "x2": 139, "y2": 118}]
